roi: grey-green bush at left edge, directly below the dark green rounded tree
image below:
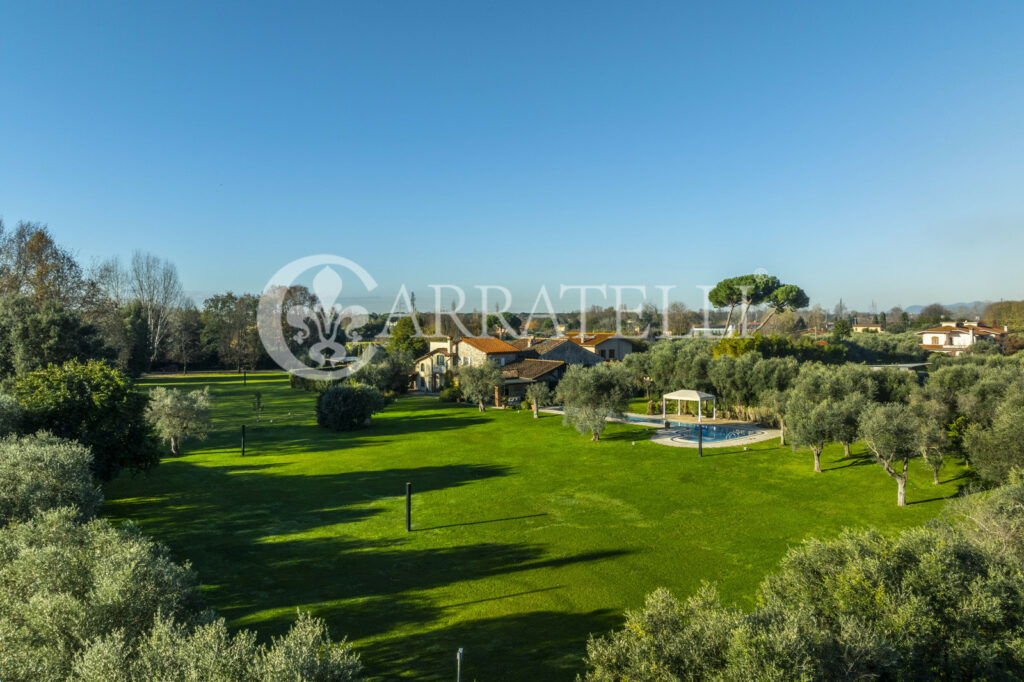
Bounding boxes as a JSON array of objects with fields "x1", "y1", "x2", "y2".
[{"x1": 0, "y1": 432, "x2": 103, "y2": 525}]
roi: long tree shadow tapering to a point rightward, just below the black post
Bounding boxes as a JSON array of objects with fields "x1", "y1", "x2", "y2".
[{"x1": 224, "y1": 538, "x2": 630, "y2": 647}]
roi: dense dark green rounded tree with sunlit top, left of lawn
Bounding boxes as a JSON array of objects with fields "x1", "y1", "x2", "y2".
[{"x1": 13, "y1": 360, "x2": 160, "y2": 480}]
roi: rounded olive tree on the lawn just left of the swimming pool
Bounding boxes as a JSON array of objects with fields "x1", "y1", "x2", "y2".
[{"x1": 556, "y1": 363, "x2": 636, "y2": 440}]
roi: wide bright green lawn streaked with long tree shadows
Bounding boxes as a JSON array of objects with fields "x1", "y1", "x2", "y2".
[{"x1": 104, "y1": 375, "x2": 962, "y2": 680}]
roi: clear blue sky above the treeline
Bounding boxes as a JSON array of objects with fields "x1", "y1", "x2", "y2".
[{"x1": 0, "y1": 0, "x2": 1024, "y2": 309}]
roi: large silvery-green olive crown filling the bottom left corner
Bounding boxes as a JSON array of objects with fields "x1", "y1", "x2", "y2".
[{"x1": 0, "y1": 508, "x2": 202, "y2": 680}]
